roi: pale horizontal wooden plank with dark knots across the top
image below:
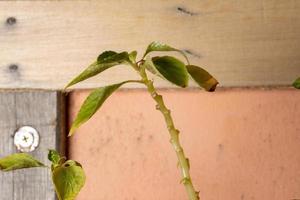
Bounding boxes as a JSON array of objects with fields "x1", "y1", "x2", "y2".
[{"x1": 0, "y1": 0, "x2": 300, "y2": 89}]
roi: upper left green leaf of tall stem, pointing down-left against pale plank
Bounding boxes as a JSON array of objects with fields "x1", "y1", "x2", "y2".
[{"x1": 65, "y1": 51, "x2": 129, "y2": 89}]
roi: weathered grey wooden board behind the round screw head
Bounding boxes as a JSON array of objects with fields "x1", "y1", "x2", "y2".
[{"x1": 0, "y1": 91, "x2": 64, "y2": 200}]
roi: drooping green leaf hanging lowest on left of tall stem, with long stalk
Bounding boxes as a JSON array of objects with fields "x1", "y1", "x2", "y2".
[{"x1": 69, "y1": 80, "x2": 140, "y2": 136}]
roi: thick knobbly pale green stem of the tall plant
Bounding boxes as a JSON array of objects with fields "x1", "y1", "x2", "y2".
[{"x1": 139, "y1": 66, "x2": 200, "y2": 200}]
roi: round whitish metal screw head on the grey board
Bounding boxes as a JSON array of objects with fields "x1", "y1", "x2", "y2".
[{"x1": 14, "y1": 126, "x2": 40, "y2": 152}]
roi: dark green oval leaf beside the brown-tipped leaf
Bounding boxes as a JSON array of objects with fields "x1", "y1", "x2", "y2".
[{"x1": 152, "y1": 56, "x2": 189, "y2": 87}]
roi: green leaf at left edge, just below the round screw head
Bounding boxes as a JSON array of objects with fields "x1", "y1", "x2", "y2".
[{"x1": 0, "y1": 153, "x2": 45, "y2": 171}]
